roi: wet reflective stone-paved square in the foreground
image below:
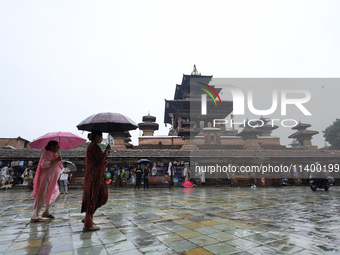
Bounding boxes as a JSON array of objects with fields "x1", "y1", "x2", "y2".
[{"x1": 0, "y1": 187, "x2": 340, "y2": 255}]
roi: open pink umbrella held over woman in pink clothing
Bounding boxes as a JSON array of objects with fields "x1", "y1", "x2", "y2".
[{"x1": 28, "y1": 131, "x2": 86, "y2": 150}]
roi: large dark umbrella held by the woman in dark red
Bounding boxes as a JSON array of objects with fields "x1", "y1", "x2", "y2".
[{"x1": 77, "y1": 112, "x2": 138, "y2": 133}]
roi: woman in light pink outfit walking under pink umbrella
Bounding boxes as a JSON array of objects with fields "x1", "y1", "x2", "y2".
[{"x1": 31, "y1": 141, "x2": 63, "y2": 222}]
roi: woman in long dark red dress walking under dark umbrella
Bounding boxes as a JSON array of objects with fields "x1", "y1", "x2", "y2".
[{"x1": 81, "y1": 130, "x2": 111, "y2": 231}]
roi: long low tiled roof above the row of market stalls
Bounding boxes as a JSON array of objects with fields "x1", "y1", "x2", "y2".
[{"x1": 0, "y1": 149, "x2": 340, "y2": 160}]
